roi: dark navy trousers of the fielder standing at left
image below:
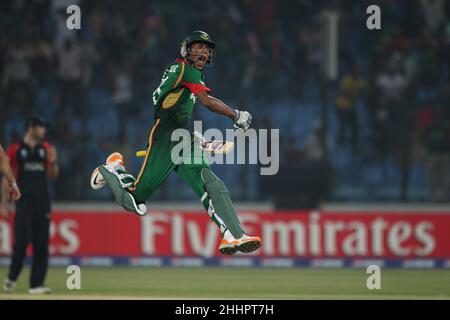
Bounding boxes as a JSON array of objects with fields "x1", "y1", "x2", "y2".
[{"x1": 8, "y1": 195, "x2": 50, "y2": 288}]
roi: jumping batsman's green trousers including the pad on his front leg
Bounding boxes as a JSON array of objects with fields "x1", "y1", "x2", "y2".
[{"x1": 129, "y1": 119, "x2": 244, "y2": 238}]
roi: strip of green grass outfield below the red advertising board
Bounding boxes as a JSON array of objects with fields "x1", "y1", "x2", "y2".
[{"x1": 0, "y1": 267, "x2": 450, "y2": 299}]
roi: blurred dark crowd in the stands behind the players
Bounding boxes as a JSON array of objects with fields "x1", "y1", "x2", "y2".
[{"x1": 0, "y1": 0, "x2": 450, "y2": 200}]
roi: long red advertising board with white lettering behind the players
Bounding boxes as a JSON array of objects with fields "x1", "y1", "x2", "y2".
[{"x1": 0, "y1": 211, "x2": 450, "y2": 259}]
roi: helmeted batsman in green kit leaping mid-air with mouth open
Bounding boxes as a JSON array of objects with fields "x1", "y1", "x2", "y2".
[{"x1": 91, "y1": 31, "x2": 261, "y2": 255}]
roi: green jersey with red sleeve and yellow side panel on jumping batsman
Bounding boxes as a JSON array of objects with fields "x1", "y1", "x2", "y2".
[{"x1": 153, "y1": 59, "x2": 211, "y2": 127}]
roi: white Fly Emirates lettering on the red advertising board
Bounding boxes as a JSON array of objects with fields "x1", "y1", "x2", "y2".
[{"x1": 141, "y1": 212, "x2": 436, "y2": 257}]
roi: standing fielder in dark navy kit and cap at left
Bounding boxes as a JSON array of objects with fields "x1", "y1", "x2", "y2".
[{"x1": 2, "y1": 117, "x2": 59, "y2": 294}]
